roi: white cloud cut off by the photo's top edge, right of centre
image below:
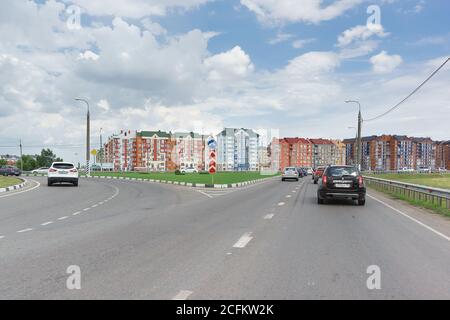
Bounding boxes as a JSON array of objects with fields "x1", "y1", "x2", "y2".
[{"x1": 241, "y1": 0, "x2": 361, "y2": 24}]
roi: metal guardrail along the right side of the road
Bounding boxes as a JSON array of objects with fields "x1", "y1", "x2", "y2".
[{"x1": 364, "y1": 176, "x2": 450, "y2": 209}]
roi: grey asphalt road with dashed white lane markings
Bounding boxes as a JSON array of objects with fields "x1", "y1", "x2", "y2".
[{"x1": 0, "y1": 178, "x2": 450, "y2": 299}]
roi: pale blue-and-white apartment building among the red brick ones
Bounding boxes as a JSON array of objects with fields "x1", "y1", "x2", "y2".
[{"x1": 217, "y1": 128, "x2": 259, "y2": 171}]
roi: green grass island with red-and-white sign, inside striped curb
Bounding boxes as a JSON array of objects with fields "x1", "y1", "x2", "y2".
[{"x1": 93, "y1": 172, "x2": 280, "y2": 184}]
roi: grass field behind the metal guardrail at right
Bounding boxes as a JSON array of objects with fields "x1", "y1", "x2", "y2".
[{"x1": 369, "y1": 173, "x2": 450, "y2": 189}]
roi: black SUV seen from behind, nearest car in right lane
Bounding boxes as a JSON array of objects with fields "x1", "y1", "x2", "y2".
[{"x1": 317, "y1": 166, "x2": 366, "y2": 206}]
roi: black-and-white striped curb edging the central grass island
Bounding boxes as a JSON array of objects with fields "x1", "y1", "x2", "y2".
[{"x1": 25, "y1": 174, "x2": 280, "y2": 189}]
